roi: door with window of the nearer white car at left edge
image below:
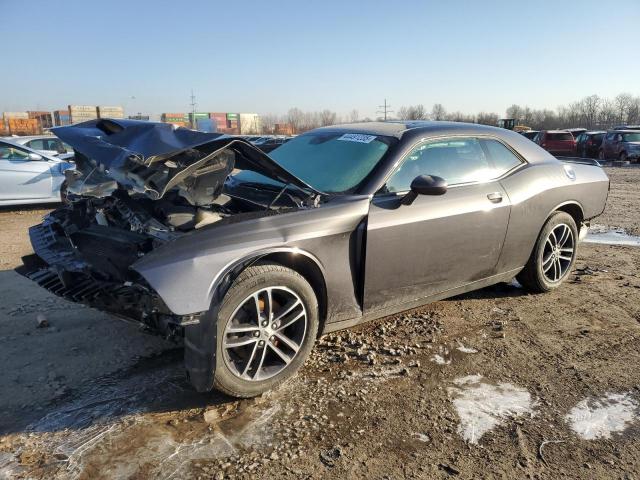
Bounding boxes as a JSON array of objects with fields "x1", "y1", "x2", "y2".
[{"x1": 0, "y1": 143, "x2": 53, "y2": 203}]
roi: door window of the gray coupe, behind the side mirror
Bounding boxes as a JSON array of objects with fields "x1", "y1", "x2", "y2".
[{"x1": 384, "y1": 137, "x2": 497, "y2": 192}]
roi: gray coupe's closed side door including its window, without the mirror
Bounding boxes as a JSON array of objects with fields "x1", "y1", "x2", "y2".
[{"x1": 364, "y1": 137, "x2": 523, "y2": 312}]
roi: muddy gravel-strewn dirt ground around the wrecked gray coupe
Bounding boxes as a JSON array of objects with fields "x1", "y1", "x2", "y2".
[{"x1": 0, "y1": 168, "x2": 640, "y2": 479}]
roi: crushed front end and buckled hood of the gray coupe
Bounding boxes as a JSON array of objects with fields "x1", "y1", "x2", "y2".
[{"x1": 18, "y1": 120, "x2": 319, "y2": 335}]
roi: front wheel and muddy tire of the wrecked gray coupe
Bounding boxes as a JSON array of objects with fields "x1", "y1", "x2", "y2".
[{"x1": 213, "y1": 264, "x2": 319, "y2": 398}]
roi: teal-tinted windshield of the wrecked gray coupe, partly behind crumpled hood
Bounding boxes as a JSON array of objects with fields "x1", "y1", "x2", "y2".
[{"x1": 234, "y1": 132, "x2": 393, "y2": 193}]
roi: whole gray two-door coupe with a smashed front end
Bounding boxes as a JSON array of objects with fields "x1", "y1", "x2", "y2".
[{"x1": 21, "y1": 120, "x2": 609, "y2": 397}]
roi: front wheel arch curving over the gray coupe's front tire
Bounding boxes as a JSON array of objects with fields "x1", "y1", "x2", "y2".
[{"x1": 210, "y1": 247, "x2": 328, "y2": 335}]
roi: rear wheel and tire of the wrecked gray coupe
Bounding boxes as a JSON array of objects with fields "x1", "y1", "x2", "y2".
[{"x1": 516, "y1": 212, "x2": 578, "y2": 293}]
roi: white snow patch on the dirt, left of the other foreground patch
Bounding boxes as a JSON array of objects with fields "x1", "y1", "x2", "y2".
[{"x1": 447, "y1": 375, "x2": 535, "y2": 444}]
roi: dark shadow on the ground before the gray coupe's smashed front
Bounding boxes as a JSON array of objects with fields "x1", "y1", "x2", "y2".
[{"x1": 0, "y1": 270, "x2": 234, "y2": 435}]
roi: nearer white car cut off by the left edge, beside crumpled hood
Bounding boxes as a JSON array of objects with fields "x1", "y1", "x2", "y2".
[{"x1": 0, "y1": 140, "x2": 74, "y2": 206}]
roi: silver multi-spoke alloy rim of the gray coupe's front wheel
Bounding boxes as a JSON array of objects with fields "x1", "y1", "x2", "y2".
[{"x1": 222, "y1": 286, "x2": 308, "y2": 381}]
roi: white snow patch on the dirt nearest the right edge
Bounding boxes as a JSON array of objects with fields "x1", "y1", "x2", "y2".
[{"x1": 565, "y1": 393, "x2": 640, "y2": 440}]
